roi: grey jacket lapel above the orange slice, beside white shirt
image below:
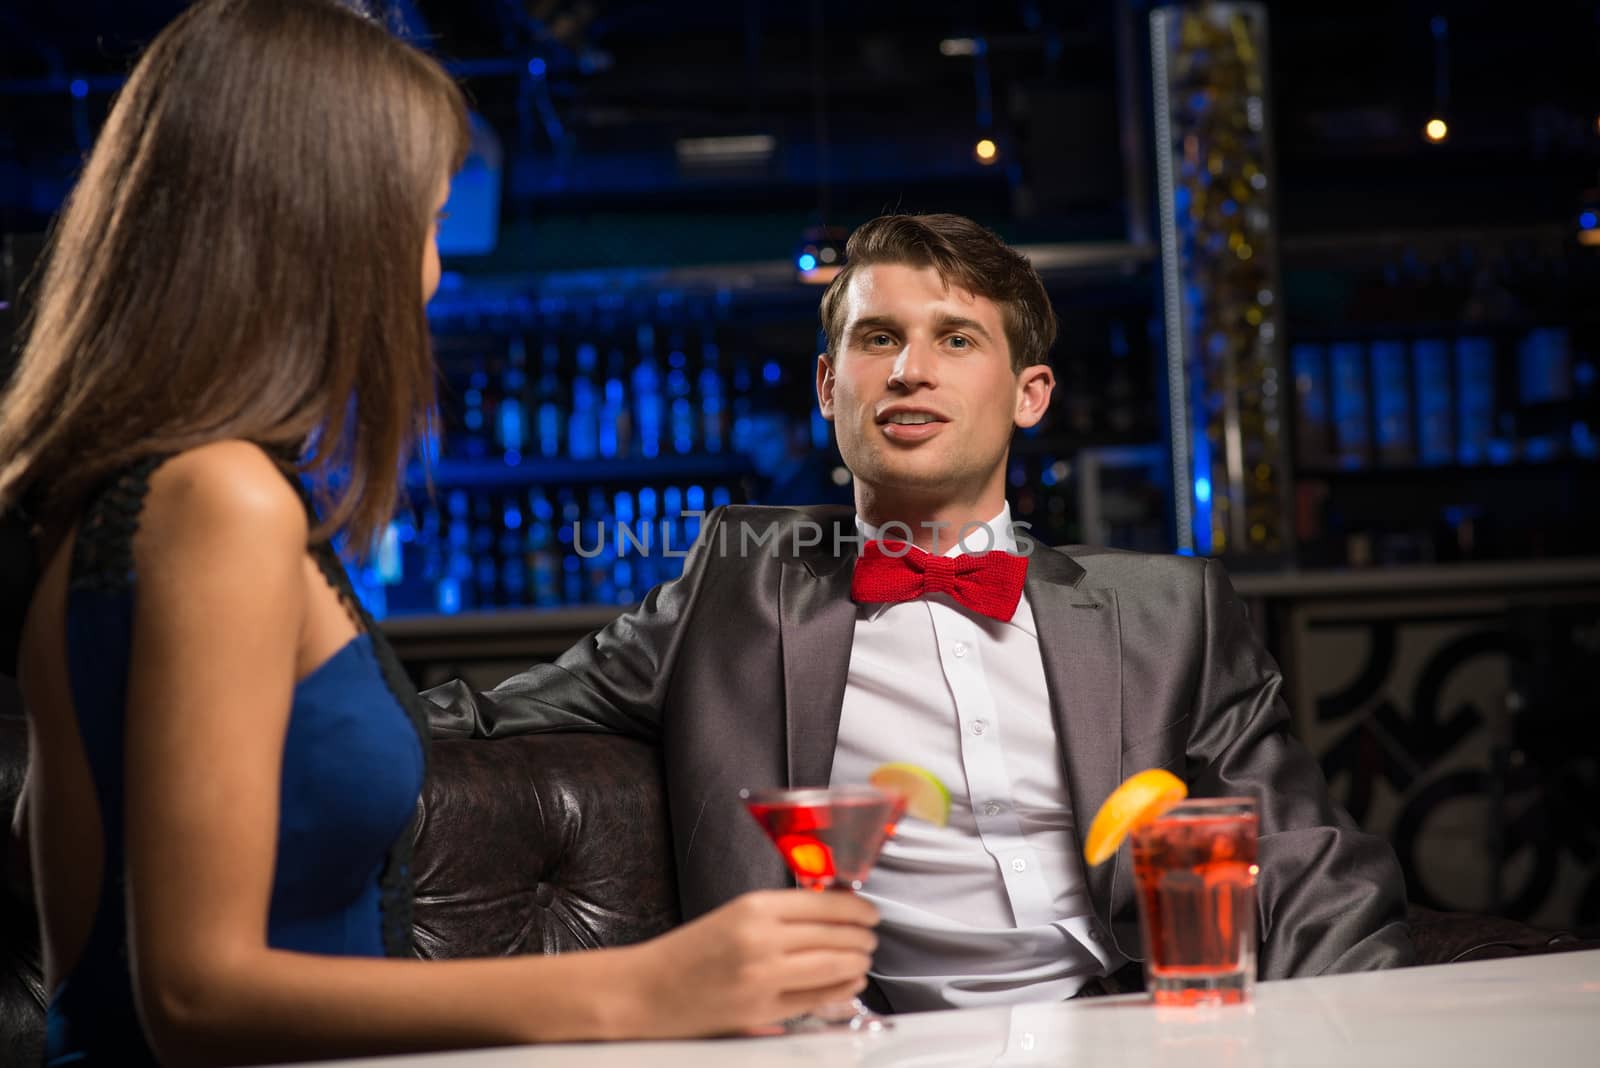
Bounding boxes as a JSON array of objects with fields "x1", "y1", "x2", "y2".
[{"x1": 1027, "y1": 542, "x2": 1126, "y2": 919}]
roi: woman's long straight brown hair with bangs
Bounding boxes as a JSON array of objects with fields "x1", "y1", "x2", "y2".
[{"x1": 0, "y1": 0, "x2": 469, "y2": 547}]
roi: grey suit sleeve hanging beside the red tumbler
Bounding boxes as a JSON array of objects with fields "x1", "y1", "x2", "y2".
[{"x1": 1189, "y1": 561, "x2": 1416, "y2": 978}]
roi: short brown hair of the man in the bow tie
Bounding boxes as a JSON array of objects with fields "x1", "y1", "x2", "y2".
[{"x1": 822, "y1": 214, "x2": 1056, "y2": 371}]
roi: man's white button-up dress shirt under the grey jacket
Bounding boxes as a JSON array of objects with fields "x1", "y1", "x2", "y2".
[{"x1": 832, "y1": 505, "x2": 1123, "y2": 1012}]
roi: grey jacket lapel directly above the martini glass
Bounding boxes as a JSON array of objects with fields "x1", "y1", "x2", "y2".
[{"x1": 778, "y1": 511, "x2": 856, "y2": 787}]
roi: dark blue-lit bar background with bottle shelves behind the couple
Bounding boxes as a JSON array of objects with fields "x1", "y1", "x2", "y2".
[{"x1": 0, "y1": 0, "x2": 1600, "y2": 929}]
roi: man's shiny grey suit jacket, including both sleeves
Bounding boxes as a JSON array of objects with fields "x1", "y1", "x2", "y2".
[{"x1": 426, "y1": 507, "x2": 1413, "y2": 978}]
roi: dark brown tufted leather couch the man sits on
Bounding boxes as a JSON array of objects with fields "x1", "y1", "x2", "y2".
[{"x1": 0, "y1": 716, "x2": 1582, "y2": 1065}]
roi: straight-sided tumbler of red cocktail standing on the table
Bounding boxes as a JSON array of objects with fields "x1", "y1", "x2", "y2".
[{"x1": 1133, "y1": 798, "x2": 1258, "y2": 1004}]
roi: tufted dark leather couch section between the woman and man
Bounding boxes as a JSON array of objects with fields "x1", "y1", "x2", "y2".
[{"x1": 414, "y1": 734, "x2": 678, "y2": 958}]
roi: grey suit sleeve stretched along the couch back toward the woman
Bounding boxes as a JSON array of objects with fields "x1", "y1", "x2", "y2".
[{"x1": 422, "y1": 508, "x2": 723, "y2": 742}]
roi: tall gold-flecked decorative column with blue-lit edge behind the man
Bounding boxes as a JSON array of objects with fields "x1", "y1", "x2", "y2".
[{"x1": 1150, "y1": 3, "x2": 1293, "y2": 564}]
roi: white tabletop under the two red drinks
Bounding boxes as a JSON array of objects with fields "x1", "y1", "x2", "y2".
[{"x1": 278, "y1": 950, "x2": 1600, "y2": 1068}]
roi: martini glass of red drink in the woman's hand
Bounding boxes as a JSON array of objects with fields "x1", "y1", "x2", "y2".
[{"x1": 739, "y1": 787, "x2": 906, "y2": 1031}]
